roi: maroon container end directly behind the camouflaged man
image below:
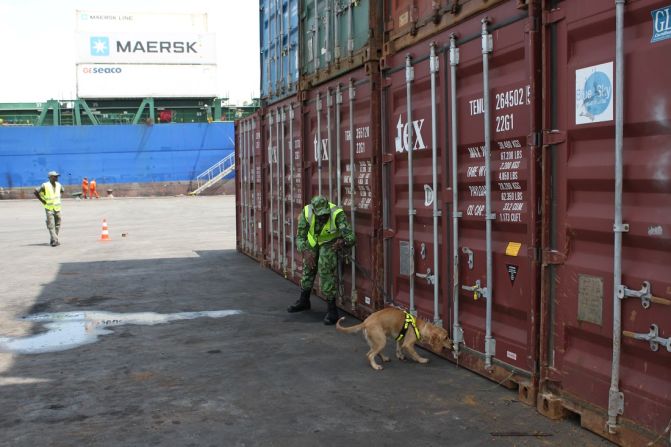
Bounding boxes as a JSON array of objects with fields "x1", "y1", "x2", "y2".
[{"x1": 303, "y1": 68, "x2": 382, "y2": 315}]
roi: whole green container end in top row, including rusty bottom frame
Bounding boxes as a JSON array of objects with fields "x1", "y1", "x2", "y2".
[{"x1": 300, "y1": 0, "x2": 383, "y2": 89}]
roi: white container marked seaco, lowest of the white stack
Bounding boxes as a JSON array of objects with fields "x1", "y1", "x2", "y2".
[{"x1": 77, "y1": 64, "x2": 217, "y2": 98}]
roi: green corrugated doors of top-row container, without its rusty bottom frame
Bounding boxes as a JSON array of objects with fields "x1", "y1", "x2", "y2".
[{"x1": 300, "y1": 0, "x2": 371, "y2": 76}]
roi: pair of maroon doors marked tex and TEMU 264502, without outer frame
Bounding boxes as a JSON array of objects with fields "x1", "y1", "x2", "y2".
[{"x1": 384, "y1": 2, "x2": 537, "y2": 382}]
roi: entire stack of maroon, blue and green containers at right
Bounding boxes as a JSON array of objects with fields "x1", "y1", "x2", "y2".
[{"x1": 236, "y1": 0, "x2": 671, "y2": 445}]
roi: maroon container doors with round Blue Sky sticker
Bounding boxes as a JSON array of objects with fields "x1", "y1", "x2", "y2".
[{"x1": 543, "y1": 1, "x2": 671, "y2": 445}]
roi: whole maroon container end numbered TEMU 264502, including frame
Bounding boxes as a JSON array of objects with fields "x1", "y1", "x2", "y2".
[{"x1": 382, "y1": 2, "x2": 539, "y2": 403}]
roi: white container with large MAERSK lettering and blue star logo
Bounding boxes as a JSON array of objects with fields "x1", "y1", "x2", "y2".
[{"x1": 75, "y1": 31, "x2": 217, "y2": 64}]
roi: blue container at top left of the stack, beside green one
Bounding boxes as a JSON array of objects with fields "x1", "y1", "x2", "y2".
[{"x1": 259, "y1": 0, "x2": 299, "y2": 104}]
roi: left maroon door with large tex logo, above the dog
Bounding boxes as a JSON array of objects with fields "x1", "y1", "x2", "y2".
[{"x1": 384, "y1": 47, "x2": 449, "y2": 322}]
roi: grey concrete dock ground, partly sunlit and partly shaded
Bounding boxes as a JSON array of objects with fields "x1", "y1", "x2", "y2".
[{"x1": 0, "y1": 196, "x2": 610, "y2": 447}]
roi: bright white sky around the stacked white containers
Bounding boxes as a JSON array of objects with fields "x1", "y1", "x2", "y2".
[{"x1": 0, "y1": 0, "x2": 260, "y2": 105}]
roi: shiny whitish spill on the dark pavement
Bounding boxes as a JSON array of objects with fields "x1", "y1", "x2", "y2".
[{"x1": 0, "y1": 310, "x2": 241, "y2": 354}]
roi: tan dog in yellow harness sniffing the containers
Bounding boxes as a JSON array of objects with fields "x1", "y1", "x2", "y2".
[{"x1": 336, "y1": 307, "x2": 452, "y2": 370}]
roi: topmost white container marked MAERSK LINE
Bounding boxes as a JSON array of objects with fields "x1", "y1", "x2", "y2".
[{"x1": 75, "y1": 10, "x2": 207, "y2": 33}]
